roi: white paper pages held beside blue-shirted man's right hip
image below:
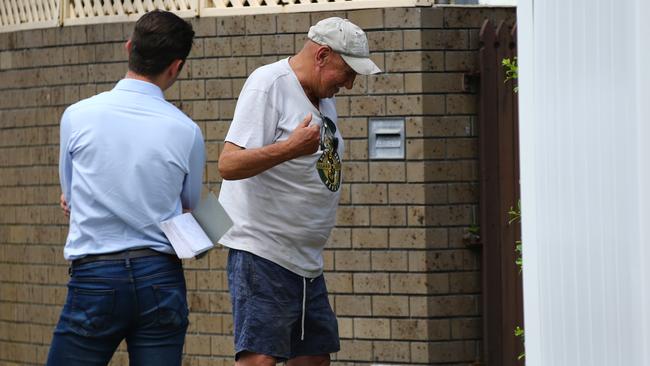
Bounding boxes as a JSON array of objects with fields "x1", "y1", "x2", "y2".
[{"x1": 160, "y1": 213, "x2": 214, "y2": 259}]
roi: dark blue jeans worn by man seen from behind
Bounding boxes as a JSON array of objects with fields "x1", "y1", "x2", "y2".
[{"x1": 47, "y1": 255, "x2": 188, "y2": 366}]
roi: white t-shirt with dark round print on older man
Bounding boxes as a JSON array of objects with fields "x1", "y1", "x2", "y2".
[{"x1": 219, "y1": 59, "x2": 343, "y2": 278}]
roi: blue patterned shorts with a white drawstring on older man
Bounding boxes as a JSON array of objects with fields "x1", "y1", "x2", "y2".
[{"x1": 228, "y1": 249, "x2": 340, "y2": 361}]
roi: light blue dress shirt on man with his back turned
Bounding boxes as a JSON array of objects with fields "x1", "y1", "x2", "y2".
[{"x1": 59, "y1": 79, "x2": 205, "y2": 260}]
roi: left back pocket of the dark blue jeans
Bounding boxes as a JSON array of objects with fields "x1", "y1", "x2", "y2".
[{"x1": 63, "y1": 287, "x2": 115, "y2": 335}]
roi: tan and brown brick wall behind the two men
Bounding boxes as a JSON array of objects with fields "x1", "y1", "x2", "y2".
[{"x1": 0, "y1": 7, "x2": 514, "y2": 365}]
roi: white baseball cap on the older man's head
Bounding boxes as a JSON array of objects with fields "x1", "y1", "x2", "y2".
[{"x1": 307, "y1": 17, "x2": 381, "y2": 75}]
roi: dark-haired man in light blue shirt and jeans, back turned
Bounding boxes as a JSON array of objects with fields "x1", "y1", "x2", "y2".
[{"x1": 47, "y1": 11, "x2": 205, "y2": 366}]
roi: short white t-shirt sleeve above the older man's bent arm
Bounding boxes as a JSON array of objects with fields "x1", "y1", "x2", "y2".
[{"x1": 225, "y1": 88, "x2": 279, "y2": 149}]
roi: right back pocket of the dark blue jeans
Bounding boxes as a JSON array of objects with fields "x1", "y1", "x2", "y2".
[{"x1": 152, "y1": 283, "x2": 189, "y2": 329}]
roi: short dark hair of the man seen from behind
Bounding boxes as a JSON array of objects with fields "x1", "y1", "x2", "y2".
[{"x1": 129, "y1": 10, "x2": 194, "y2": 76}]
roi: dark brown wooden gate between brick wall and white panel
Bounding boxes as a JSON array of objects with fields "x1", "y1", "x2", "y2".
[{"x1": 479, "y1": 20, "x2": 524, "y2": 366}]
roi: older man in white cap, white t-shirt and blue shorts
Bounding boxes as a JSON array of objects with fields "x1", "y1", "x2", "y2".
[{"x1": 219, "y1": 17, "x2": 380, "y2": 366}]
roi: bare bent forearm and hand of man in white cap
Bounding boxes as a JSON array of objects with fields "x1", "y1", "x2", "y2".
[{"x1": 219, "y1": 113, "x2": 320, "y2": 180}]
